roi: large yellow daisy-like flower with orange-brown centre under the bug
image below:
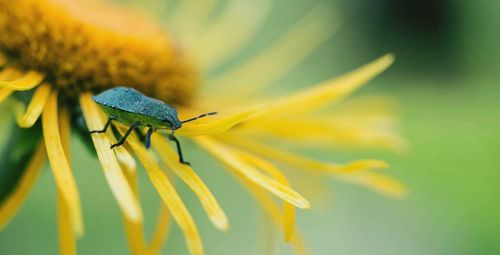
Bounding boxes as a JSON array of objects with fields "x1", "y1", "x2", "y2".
[{"x1": 0, "y1": 0, "x2": 404, "y2": 254}]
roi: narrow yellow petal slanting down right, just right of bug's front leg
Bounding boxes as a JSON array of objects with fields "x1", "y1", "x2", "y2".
[{"x1": 195, "y1": 137, "x2": 310, "y2": 209}]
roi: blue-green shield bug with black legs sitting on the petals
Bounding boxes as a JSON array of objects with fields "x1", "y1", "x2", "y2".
[{"x1": 90, "y1": 87, "x2": 217, "y2": 165}]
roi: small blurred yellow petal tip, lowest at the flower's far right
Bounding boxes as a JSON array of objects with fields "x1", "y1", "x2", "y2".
[{"x1": 340, "y1": 172, "x2": 407, "y2": 198}]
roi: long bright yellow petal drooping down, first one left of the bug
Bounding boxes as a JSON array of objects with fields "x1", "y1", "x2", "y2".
[{"x1": 42, "y1": 92, "x2": 83, "y2": 236}]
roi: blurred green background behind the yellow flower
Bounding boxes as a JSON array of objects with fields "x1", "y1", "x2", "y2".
[{"x1": 0, "y1": 0, "x2": 500, "y2": 255}]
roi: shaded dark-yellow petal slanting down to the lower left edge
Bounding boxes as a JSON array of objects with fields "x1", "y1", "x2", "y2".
[{"x1": 0, "y1": 142, "x2": 45, "y2": 230}]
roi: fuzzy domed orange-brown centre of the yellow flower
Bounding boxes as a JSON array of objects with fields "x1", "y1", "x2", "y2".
[{"x1": 0, "y1": 0, "x2": 197, "y2": 104}]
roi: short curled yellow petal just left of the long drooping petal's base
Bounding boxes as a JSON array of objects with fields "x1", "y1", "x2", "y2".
[{"x1": 17, "y1": 83, "x2": 51, "y2": 128}]
